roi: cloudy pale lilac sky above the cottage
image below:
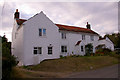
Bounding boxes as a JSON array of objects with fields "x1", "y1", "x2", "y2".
[{"x1": 0, "y1": 0, "x2": 118, "y2": 41}]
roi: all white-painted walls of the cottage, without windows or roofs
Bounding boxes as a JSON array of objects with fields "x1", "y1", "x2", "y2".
[{"x1": 12, "y1": 12, "x2": 114, "y2": 65}]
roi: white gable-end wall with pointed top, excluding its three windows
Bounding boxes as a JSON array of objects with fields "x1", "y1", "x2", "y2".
[{"x1": 24, "y1": 12, "x2": 60, "y2": 65}]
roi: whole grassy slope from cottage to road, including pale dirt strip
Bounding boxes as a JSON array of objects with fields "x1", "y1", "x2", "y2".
[{"x1": 11, "y1": 56, "x2": 118, "y2": 77}]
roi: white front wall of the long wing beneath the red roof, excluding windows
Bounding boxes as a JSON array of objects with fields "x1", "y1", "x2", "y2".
[{"x1": 60, "y1": 31, "x2": 99, "y2": 55}]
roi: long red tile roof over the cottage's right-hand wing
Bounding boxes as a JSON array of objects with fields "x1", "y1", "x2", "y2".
[{"x1": 55, "y1": 24, "x2": 99, "y2": 35}]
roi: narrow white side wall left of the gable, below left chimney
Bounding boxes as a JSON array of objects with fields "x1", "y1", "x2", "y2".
[{"x1": 11, "y1": 21, "x2": 24, "y2": 63}]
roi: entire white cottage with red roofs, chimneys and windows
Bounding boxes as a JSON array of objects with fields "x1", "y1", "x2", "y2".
[{"x1": 12, "y1": 9, "x2": 114, "y2": 65}]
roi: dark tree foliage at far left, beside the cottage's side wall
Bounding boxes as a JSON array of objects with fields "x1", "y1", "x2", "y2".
[{"x1": 0, "y1": 35, "x2": 17, "y2": 80}]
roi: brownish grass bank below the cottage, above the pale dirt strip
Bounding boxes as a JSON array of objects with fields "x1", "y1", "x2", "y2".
[{"x1": 23, "y1": 56, "x2": 118, "y2": 72}]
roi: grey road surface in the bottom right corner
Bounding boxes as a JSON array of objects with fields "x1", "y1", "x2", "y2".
[{"x1": 66, "y1": 64, "x2": 120, "y2": 78}]
